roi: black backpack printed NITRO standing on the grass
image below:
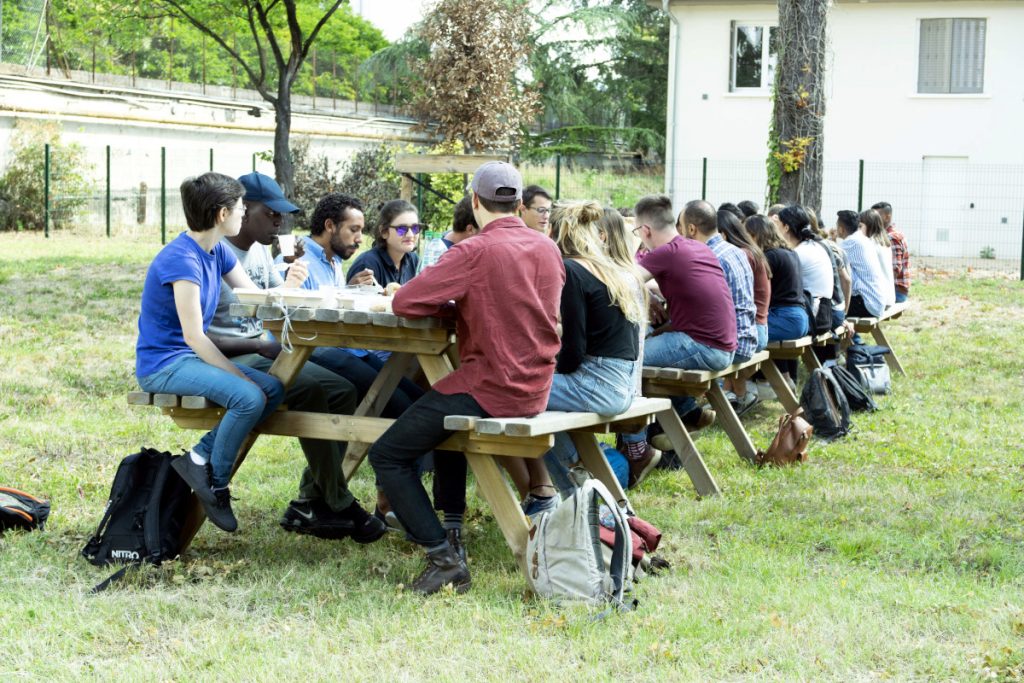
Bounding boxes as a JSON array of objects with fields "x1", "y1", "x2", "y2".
[{"x1": 82, "y1": 449, "x2": 191, "y2": 592}]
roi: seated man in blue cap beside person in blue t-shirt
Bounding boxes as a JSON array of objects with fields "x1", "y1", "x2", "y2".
[{"x1": 208, "y1": 173, "x2": 387, "y2": 543}]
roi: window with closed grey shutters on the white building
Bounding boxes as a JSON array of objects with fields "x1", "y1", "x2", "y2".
[{"x1": 918, "y1": 19, "x2": 985, "y2": 93}]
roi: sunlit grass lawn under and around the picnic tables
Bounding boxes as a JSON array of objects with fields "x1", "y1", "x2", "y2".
[{"x1": 0, "y1": 234, "x2": 1024, "y2": 681}]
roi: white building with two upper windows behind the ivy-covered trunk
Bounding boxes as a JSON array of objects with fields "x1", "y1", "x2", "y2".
[{"x1": 649, "y1": 0, "x2": 1024, "y2": 259}]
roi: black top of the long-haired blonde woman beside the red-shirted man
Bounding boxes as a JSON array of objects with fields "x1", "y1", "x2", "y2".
[{"x1": 555, "y1": 258, "x2": 640, "y2": 375}]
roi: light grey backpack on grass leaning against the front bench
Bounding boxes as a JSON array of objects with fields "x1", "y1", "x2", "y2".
[{"x1": 526, "y1": 479, "x2": 633, "y2": 608}]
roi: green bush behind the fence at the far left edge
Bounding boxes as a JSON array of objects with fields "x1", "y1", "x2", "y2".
[{"x1": 0, "y1": 119, "x2": 92, "y2": 230}]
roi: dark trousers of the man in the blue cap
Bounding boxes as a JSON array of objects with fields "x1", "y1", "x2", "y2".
[{"x1": 231, "y1": 353, "x2": 357, "y2": 512}]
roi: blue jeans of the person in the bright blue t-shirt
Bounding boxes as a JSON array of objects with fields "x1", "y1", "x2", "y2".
[{"x1": 138, "y1": 353, "x2": 285, "y2": 487}]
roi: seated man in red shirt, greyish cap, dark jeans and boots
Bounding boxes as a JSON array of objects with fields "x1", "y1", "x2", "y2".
[{"x1": 370, "y1": 162, "x2": 565, "y2": 594}]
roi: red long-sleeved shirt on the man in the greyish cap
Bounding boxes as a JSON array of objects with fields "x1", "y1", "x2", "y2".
[{"x1": 391, "y1": 216, "x2": 565, "y2": 418}]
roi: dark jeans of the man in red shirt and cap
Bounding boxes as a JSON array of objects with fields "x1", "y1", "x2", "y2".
[{"x1": 370, "y1": 389, "x2": 489, "y2": 548}]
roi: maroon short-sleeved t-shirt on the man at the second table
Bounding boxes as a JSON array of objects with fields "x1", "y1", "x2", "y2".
[{"x1": 640, "y1": 236, "x2": 736, "y2": 351}]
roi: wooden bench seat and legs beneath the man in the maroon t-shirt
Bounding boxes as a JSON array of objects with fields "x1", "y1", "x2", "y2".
[{"x1": 643, "y1": 352, "x2": 786, "y2": 463}]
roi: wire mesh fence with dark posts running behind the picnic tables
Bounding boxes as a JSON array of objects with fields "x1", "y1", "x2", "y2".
[{"x1": 9, "y1": 145, "x2": 1024, "y2": 279}]
